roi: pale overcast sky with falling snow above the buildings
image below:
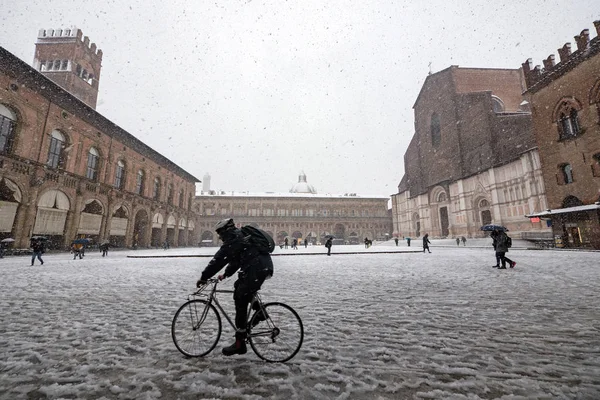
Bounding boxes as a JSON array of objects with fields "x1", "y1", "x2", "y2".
[{"x1": 0, "y1": 0, "x2": 600, "y2": 195}]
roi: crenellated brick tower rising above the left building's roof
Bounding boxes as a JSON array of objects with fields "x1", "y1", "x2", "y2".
[{"x1": 33, "y1": 28, "x2": 102, "y2": 109}]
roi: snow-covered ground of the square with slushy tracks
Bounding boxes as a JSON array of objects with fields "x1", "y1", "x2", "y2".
[{"x1": 0, "y1": 239, "x2": 600, "y2": 400}]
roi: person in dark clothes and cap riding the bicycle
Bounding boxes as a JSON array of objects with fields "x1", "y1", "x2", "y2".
[{"x1": 196, "y1": 218, "x2": 273, "y2": 356}]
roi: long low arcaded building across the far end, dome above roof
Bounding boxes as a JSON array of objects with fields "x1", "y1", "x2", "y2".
[{"x1": 194, "y1": 173, "x2": 392, "y2": 245}]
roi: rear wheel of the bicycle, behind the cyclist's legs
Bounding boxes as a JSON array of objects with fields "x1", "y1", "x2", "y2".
[{"x1": 248, "y1": 303, "x2": 304, "y2": 362}]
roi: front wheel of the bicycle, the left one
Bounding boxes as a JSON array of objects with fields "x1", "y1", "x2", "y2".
[{"x1": 171, "y1": 299, "x2": 222, "y2": 357}]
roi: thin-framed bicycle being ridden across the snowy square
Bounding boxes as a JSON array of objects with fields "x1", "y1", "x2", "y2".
[{"x1": 171, "y1": 278, "x2": 304, "y2": 362}]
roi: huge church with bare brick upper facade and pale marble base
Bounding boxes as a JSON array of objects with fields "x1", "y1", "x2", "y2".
[{"x1": 392, "y1": 66, "x2": 549, "y2": 237}]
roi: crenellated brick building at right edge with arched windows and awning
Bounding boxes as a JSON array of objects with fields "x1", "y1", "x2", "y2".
[{"x1": 523, "y1": 21, "x2": 600, "y2": 249}]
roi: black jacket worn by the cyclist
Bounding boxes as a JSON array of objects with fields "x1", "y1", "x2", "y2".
[{"x1": 200, "y1": 228, "x2": 273, "y2": 280}]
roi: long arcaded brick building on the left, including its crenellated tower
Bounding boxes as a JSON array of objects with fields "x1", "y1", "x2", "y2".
[{"x1": 0, "y1": 29, "x2": 199, "y2": 248}]
